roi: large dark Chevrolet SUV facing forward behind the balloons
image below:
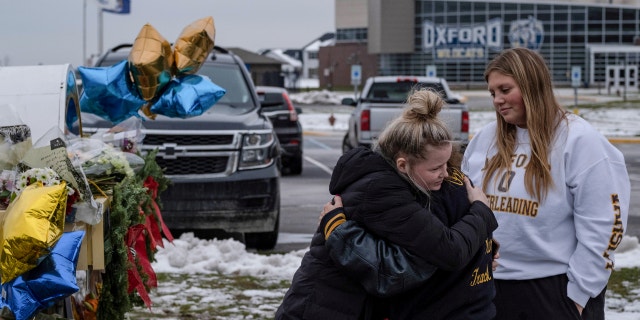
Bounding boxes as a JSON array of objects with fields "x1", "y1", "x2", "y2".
[{"x1": 82, "y1": 45, "x2": 281, "y2": 249}]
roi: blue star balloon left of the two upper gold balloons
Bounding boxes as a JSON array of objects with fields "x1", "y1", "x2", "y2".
[{"x1": 78, "y1": 60, "x2": 146, "y2": 124}]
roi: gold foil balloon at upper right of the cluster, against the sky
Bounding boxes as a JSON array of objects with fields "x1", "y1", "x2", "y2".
[{"x1": 174, "y1": 17, "x2": 216, "y2": 76}]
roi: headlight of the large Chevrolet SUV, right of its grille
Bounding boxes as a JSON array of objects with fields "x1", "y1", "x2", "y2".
[{"x1": 238, "y1": 132, "x2": 276, "y2": 170}]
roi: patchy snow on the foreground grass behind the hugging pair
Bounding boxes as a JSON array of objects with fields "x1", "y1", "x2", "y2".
[{"x1": 141, "y1": 233, "x2": 640, "y2": 320}]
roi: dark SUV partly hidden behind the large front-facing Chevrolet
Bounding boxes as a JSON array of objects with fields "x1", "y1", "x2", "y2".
[{"x1": 256, "y1": 86, "x2": 302, "y2": 175}]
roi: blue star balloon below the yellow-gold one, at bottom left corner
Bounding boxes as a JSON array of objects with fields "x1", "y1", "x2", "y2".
[{"x1": 0, "y1": 231, "x2": 84, "y2": 320}]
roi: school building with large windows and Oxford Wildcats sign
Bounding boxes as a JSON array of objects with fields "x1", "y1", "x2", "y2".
[{"x1": 318, "y1": 0, "x2": 640, "y2": 91}]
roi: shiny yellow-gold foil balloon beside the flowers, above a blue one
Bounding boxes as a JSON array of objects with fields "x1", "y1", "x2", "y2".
[{"x1": 0, "y1": 181, "x2": 67, "y2": 284}]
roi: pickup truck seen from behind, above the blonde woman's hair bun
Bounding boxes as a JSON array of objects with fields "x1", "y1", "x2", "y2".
[{"x1": 342, "y1": 76, "x2": 469, "y2": 152}]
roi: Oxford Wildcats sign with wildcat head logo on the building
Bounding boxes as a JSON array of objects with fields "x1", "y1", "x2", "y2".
[{"x1": 422, "y1": 17, "x2": 544, "y2": 60}]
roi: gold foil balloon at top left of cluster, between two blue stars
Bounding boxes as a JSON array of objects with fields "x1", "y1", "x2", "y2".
[{"x1": 128, "y1": 23, "x2": 173, "y2": 101}]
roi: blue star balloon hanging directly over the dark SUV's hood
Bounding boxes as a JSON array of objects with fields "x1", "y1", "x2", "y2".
[{"x1": 151, "y1": 75, "x2": 227, "y2": 119}]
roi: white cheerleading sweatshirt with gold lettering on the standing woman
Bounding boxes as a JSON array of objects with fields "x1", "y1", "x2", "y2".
[{"x1": 462, "y1": 114, "x2": 631, "y2": 306}]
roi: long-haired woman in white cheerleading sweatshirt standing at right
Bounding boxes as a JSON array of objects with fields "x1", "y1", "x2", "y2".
[{"x1": 462, "y1": 48, "x2": 631, "y2": 320}]
